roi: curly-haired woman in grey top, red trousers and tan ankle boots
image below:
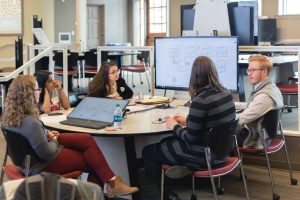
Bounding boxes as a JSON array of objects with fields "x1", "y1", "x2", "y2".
[{"x1": 2, "y1": 75, "x2": 138, "y2": 197}]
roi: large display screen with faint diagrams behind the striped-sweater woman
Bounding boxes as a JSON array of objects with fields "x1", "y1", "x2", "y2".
[{"x1": 154, "y1": 36, "x2": 238, "y2": 91}]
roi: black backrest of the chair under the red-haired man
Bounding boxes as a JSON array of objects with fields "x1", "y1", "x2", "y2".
[{"x1": 262, "y1": 109, "x2": 281, "y2": 139}]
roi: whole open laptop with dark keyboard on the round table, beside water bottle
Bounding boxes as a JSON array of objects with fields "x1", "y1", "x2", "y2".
[{"x1": 60, "y1": 97, "x2": 129, "y2": 129}]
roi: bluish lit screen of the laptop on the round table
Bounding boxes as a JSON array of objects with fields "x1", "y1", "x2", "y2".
[{"x1": 67, "y1": 97, "x2": 129, "y2": 123}]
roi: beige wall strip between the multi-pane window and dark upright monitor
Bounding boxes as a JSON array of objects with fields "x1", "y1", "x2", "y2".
[{"x1": 169, "y1": 0, "x2": 196, "y2": 37}]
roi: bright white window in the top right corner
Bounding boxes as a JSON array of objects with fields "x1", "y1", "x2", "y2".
[{"x1": 278, "y1": 0, "x2": 300, "y2": 15}]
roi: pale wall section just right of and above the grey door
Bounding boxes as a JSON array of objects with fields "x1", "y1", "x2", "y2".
[{"x1": 87, "y1": 0, "x2": 129, "y2": 44}]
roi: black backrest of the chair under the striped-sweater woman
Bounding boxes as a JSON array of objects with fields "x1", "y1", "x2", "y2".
[{"x1": 209, "y1": 120, "x2": 238, "y2": 159}]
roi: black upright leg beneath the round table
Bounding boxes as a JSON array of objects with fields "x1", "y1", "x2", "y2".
[{"x1": 124, "y1": 137, "x2": 143, "y2": 200}]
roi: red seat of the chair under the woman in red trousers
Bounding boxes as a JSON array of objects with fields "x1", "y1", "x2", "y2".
[{"x1": 3, "y1": 164, "x2": 82, "y2": 180}]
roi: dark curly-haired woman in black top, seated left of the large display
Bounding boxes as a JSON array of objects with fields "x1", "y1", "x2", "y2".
[{"x1": 88, "y1": 63, "x2": 133, "y2": 99}]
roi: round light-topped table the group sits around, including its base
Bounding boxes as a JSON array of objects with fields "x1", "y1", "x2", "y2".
[{"x1": 41, "y1": 100, "x2": 188, "y2": 200}]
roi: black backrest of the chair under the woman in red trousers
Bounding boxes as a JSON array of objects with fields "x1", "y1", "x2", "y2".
[{"x1": 2, "y1": 127, "x2": 38, "y2": 168}]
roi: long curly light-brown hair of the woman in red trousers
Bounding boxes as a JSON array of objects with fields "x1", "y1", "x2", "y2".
[{"x1": 2, "y1": 75, "x2": 39, "y2": 126}]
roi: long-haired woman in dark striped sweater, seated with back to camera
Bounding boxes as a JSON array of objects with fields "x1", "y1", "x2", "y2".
[{"x1": 143, "y1": 56, "x2": 235, "y2": 199}]
